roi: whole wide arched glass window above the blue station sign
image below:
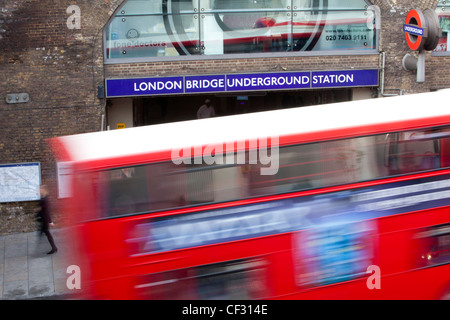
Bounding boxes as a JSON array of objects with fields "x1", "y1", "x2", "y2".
[{"x1": 105, "y1": 0, "x2": 377, "y2": 62}]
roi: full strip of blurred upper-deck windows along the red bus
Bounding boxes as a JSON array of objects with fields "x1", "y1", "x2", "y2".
[{"x1": 91, "y1": 127, "x2": 450, "y2": 218}]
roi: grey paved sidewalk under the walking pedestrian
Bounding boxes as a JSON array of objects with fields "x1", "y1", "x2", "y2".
[{"x1": 0, "y1": 228, "x2": 80, "y2": 300}]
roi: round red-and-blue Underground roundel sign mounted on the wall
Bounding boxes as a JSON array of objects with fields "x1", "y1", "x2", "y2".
[{"x1": 403, "y1": 9, "x2": 442, "y2": 51}]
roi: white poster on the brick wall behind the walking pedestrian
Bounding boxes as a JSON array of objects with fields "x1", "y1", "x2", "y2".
[{"x1": 0, "y1": 163, "x2": 41, "y2": 202}]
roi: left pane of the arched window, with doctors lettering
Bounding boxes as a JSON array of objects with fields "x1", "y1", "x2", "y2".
[{"x1": 105, "y1": 0, "x2": 199, "y2": 59}]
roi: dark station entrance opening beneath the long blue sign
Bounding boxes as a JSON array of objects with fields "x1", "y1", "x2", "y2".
[{"x1": 106, "y1": 88, "x2": 372, "y2": 130}]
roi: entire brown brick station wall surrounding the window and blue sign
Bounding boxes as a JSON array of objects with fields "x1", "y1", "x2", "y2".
[{"x1": 0, "y1": 0, "x2": 450, "y2": 234}]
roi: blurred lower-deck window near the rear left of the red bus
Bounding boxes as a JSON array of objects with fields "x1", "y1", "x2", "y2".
[{"x1": 135, "y1": 259, "x2": 267, "y2": 300}]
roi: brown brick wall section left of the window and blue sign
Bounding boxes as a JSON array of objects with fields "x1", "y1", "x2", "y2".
[{"x1": 0, "y1": 0, "x2": 121, "y2": 234}]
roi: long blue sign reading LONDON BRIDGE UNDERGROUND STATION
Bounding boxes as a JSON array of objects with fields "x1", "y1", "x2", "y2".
[{"x1": 106, "y1": 69, "x2": 378, "y2": 98}]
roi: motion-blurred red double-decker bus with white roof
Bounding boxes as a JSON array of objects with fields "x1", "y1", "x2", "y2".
[{"x1": 52, "y1": 91, "x2": 450, "y2": 299}]
